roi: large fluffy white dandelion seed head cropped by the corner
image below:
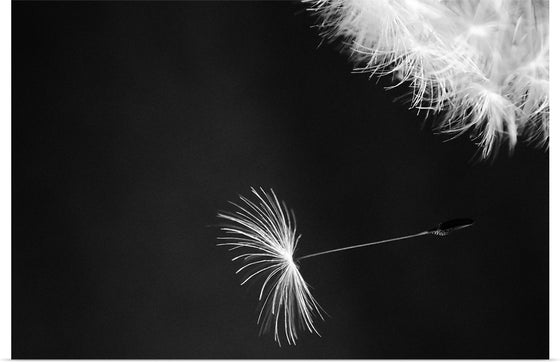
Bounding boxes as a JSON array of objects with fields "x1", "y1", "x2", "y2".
[{"x1": 304, "y1": 0, "x2": 549, "y2": 158}]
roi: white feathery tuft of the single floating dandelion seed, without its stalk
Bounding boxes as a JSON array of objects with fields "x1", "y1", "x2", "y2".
[{"x1": 218, "y1": 188, "x2": 323, "y2": 345}]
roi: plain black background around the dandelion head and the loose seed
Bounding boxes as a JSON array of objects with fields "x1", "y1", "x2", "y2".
[{"x1": 12, "y1": 2, "x2": 548, "y2": 358}]
